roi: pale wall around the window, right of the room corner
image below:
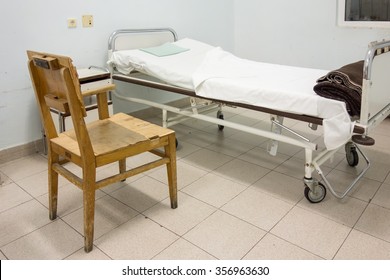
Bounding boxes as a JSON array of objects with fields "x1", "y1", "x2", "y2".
[{"x1": 235, "y1": 0, "x2": 390, "y2": 69}]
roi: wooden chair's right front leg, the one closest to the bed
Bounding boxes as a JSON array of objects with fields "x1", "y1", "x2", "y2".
[{"x1": 164, "y1": 134, "x2": 177, "y2": 209}]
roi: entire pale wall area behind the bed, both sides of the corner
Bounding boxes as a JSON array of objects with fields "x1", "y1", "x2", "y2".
[{"x1": 0, "y1": 0, "x2": 390, "y2": 150}]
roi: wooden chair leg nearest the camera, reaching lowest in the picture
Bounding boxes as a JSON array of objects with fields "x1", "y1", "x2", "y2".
[{"x1": 83, "y1": 168, "x2": 96, "y2": 253}]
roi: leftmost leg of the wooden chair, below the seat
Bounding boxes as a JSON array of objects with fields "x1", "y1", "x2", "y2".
[{"x1": 48, "y1": 150, "x2": 59, "y2": 220}]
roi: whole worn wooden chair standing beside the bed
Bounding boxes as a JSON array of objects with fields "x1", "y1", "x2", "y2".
[{"x1": 27, "y1": 51, "x2": 177, "y2": 252}]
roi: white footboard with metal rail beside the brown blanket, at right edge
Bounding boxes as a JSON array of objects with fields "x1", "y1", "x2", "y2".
[{"x1": 359, "y1": 38, "x2": 390, "y2": 131}]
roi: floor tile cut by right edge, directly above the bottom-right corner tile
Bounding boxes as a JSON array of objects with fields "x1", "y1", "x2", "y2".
[{"x1": 355, "y1": 204, "x2": 390, "y2": 242}]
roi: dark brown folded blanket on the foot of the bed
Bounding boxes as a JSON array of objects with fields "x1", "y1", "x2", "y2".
[{"x1": 313, "y1": 60, "x2": 364, "y2": 116}]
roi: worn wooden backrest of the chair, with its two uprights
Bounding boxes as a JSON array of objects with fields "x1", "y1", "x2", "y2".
[{"x1": 27, "y1": 51, "x2": 92, "y2": 159}]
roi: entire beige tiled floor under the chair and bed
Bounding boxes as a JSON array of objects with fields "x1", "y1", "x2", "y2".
[{"x1": 0, "y1": 109, "x2": 390, "y2": 259}]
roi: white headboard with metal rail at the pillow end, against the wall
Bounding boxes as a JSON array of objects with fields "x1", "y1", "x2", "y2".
[{"x1": 108, "y1": 28, "x2": 177, "y2": 54}]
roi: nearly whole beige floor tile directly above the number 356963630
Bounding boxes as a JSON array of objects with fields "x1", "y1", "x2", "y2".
[{"x1": 183, "y1": 211, "x2": 265, "y2": 260}]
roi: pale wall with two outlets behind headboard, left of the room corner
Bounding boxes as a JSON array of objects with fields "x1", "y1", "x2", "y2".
[{"x1": 0, "y1": 0, "x2": 234, "y2": 150}]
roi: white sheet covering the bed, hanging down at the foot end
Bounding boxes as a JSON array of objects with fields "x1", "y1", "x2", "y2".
[{"x1": 109, "y1": 39, "x2": 354, "y2": 150}]
